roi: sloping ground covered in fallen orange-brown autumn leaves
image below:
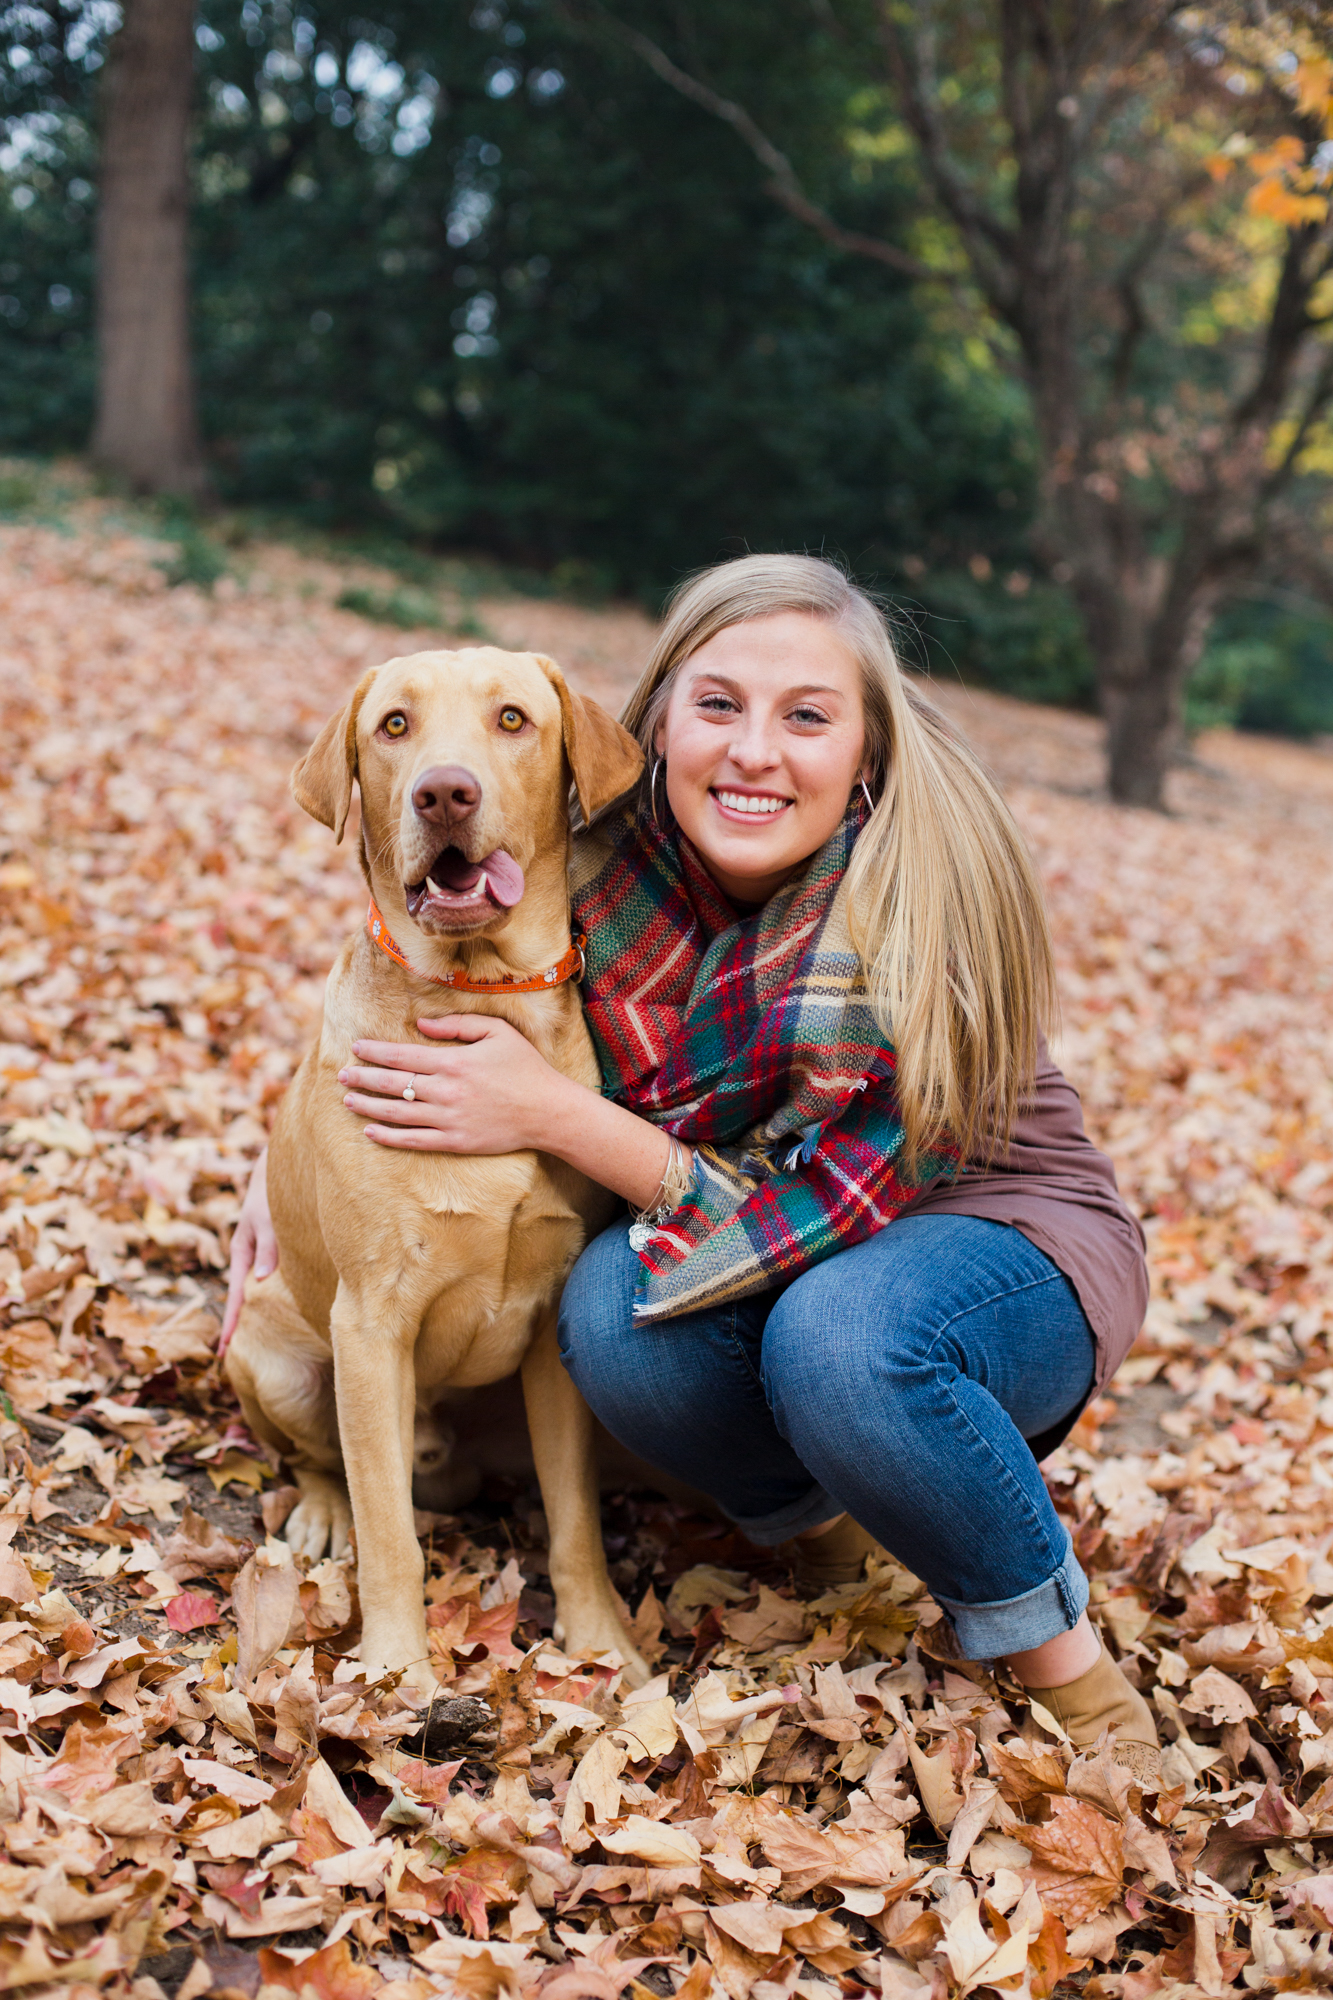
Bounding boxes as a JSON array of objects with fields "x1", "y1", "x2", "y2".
[{"x1": 0, "y1": 488, "x2": 1333, "y2": 2000}]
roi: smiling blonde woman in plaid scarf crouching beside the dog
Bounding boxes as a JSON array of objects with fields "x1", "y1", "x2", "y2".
[{"x1": 228, "y1": 556, "x2": 1157, "y2": 1778}]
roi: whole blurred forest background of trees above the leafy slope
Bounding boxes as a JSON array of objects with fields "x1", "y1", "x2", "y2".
[{"x1": 0, "y1": 0, "x2": 1333, "y2": 804}]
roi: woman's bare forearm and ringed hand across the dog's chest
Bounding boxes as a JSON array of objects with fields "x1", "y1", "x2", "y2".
[{"x1": 338, "y1": 1014, "x2": 673, "y2": 1208}]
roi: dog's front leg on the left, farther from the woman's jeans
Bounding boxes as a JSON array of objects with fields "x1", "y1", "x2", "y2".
[{"x1": 330, "y1": 1284, "x2": 436, "y2": 1700}]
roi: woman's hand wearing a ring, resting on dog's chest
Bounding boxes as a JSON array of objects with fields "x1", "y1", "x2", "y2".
[{"x1": 338, "y1": 1014, "x2": 568, "y2": 1154}]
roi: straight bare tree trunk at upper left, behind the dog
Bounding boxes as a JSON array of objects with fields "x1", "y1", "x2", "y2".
[{"x1": 92, "y1": 0, "x2": 206, "y2": 496}]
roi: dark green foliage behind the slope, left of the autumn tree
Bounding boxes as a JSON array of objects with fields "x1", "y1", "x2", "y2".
[{"x1": 0, "y1": 0, "x2": 1031, "y2": 602}]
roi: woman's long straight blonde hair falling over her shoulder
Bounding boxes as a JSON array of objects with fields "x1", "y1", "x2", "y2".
[{"x1": 622, "y1": 556, "x2": 1055, "y2": 1166}]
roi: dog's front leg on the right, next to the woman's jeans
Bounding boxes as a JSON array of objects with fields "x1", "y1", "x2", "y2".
[{"x1": 522, "y1": 1314, "x2": 648, "y2": 1688}]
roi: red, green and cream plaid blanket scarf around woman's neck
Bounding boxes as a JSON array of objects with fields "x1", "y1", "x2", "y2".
[{"x1": 572, "y1": 802, "x2": 951, "y2": 1322}]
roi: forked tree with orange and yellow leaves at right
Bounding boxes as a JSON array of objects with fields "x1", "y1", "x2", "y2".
[{"x1": 600, "y1": 0, "x2": 1333, "y2": 806}]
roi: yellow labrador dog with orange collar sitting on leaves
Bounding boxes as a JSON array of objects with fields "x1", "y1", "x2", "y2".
[{"x1": 226, "y1": 646, "x2": 646, "y2": 1698}]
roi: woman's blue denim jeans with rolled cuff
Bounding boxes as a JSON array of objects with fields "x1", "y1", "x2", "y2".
[{"x1": 560, "y1": 1216, "x2": 1095, "y2": 1660}]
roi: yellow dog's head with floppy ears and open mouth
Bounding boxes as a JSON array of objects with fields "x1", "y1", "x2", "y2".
[{"x1": 292, "y1": 646, "x2": 642, "y2": 936}]
